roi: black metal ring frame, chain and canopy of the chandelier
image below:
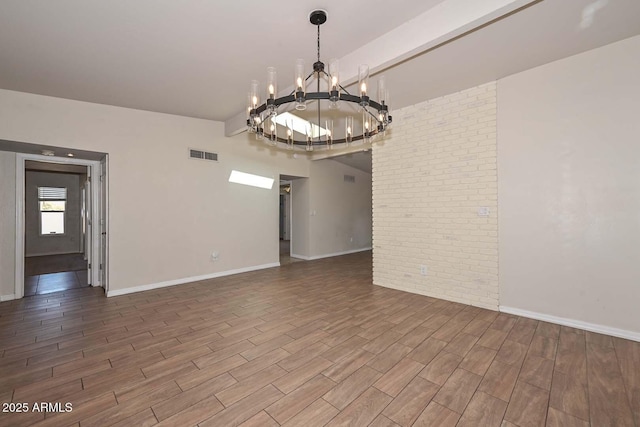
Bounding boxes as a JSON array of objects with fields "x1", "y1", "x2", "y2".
[{"x1": 247, "y1": 10, "x2": 393, "y2": 149}]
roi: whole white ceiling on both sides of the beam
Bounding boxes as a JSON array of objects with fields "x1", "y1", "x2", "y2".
[{"x1": 0, "y1": 0, "x2": 640, "y2": 125}]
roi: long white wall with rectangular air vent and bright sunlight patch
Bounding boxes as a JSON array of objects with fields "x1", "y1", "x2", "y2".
[{"x1": 0, "y1": 90, "x2": 309, "y2": 295}]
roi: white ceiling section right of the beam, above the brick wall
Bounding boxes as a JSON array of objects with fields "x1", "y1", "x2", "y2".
[{"x1": 376, "y1": 0, "x2": 640, "y2": 108}]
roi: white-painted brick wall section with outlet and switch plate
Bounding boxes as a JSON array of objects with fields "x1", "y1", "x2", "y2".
[{"x1": 372, "y1": 82, "x2": 498, "y2": 310}]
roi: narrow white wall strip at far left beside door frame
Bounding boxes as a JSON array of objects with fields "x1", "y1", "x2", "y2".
[{"x1": 0, "y1": 151, "x2": 16, "y2": 301}]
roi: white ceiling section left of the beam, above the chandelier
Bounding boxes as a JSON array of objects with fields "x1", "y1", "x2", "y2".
[{"x1": 0, "y1": 0, "x2": 442, "y2": 120}]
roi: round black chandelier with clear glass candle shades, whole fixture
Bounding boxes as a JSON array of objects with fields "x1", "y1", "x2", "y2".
[{"x1": 247, "y1": 10, "x2": 391, "y2": 151}]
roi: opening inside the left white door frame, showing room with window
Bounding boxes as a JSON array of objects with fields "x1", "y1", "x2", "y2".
[{"x1": 24, "y1": 160, "x2": 90, "y2": 296}]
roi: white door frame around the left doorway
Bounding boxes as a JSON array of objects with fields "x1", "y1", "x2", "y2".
[{"x1": 15, "y1": 153, "x2": 108, "y2": 299}]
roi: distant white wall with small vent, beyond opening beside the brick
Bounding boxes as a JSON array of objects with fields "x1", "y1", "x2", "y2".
[{"x1": 306, "y1": 159, "x2": 371, "y2": 258}]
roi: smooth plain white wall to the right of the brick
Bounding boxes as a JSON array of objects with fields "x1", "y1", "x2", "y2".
[{"x1": 498, "y1": 36, "x2": 640, "y2": 337}]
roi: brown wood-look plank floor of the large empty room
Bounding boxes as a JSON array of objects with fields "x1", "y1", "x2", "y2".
[{"x1": 0, "y1": 253, "x2": 640, "y2": 427}]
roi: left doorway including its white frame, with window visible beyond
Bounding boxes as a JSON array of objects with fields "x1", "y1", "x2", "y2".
[{"x1": 15, "y1": 153, "x2": 108, "y2": 298}]
